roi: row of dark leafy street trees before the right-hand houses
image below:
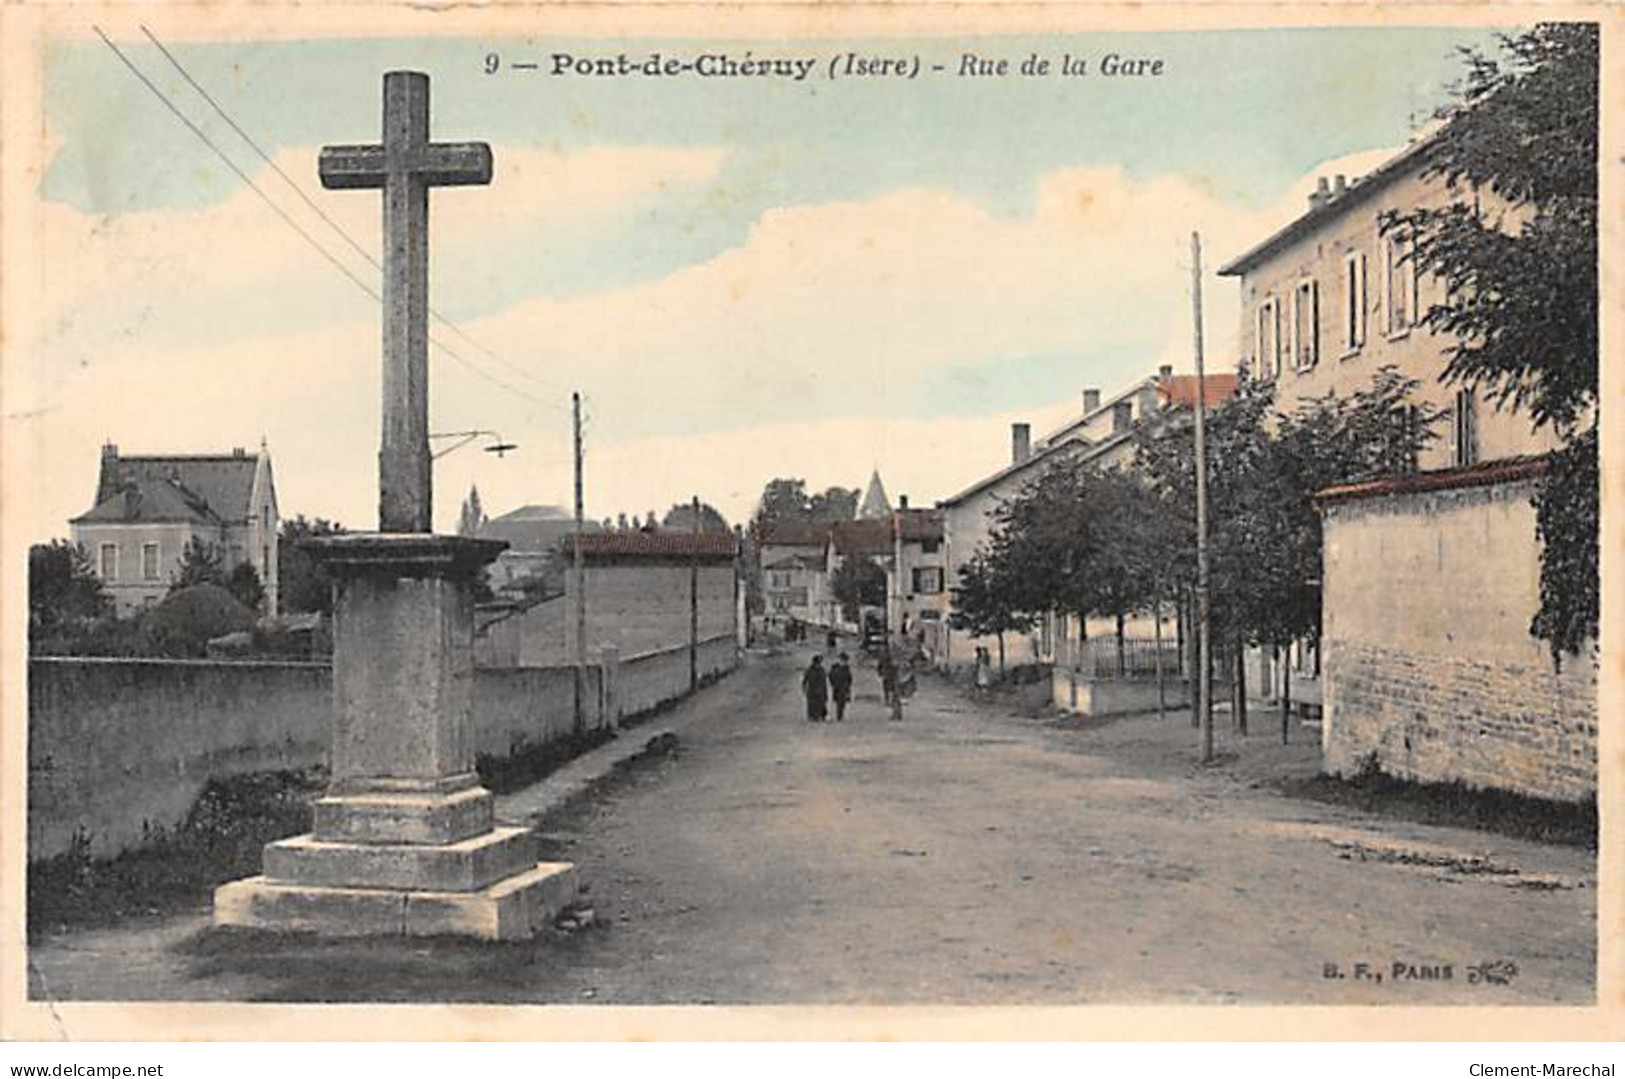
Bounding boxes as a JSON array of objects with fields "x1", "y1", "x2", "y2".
[{"x1": 951, "y1": 367, "x2": 1443, "y2": 695}]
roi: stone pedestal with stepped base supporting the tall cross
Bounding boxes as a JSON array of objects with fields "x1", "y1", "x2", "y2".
[{"x1": 215, "y1": 533, "x2": 575, "y2": 941}]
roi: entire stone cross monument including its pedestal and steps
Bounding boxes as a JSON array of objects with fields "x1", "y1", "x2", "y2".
[{"x1": 215, "y1": 72, "x2": 575, "y2": 939}]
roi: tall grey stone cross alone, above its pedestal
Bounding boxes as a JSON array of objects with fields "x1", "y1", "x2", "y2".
[{"x1": 319, "y1": 72, "x2": 491, "y2": 533}]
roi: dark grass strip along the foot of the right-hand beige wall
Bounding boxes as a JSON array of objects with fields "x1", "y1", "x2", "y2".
[{"x1": 1276, "y1": 767, "x2": 1597, "y2": 852}]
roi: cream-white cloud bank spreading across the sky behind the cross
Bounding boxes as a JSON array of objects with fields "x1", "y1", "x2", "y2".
[{"x1": 5, "y1": 148, "x2": 1410, "y2": 536}]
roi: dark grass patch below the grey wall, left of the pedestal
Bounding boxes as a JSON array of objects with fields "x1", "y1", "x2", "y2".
[{"x1": 28, "y1": 769, "x2": 327, "y2": 938}]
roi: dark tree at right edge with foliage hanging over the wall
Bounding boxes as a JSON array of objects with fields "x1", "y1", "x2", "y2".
[{"x1": 1383, "y1": 23, "x2": 1599, "y2": 653}]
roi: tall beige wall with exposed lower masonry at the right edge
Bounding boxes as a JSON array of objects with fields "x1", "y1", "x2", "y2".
[{"x1": 1323, "y1": 479, "x2": 1597, "y2": 801}]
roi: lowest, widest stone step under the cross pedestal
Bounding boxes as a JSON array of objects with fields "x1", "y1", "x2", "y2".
[{"x1": 215, "y1": 861, "x2": 577, "y2": 941}]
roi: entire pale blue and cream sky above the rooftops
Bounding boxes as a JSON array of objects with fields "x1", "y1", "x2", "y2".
[{"x1": 22, "y1": 20, "x2": 1490, "y2": 522}]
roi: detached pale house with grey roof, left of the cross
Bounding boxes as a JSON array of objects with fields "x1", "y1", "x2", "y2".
[{"x1": 68, "y1": 442, "x2": 281, "y2": 614}]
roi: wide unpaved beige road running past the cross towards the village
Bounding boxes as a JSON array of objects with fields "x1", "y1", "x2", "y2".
[{"x1": 36, "y1": 640, "x2": 1596, "y2": 1004}]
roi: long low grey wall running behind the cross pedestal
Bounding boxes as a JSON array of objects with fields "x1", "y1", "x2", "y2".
[{"x1": 28, "y1": 627, "x2": 738, "y2": 861}]
